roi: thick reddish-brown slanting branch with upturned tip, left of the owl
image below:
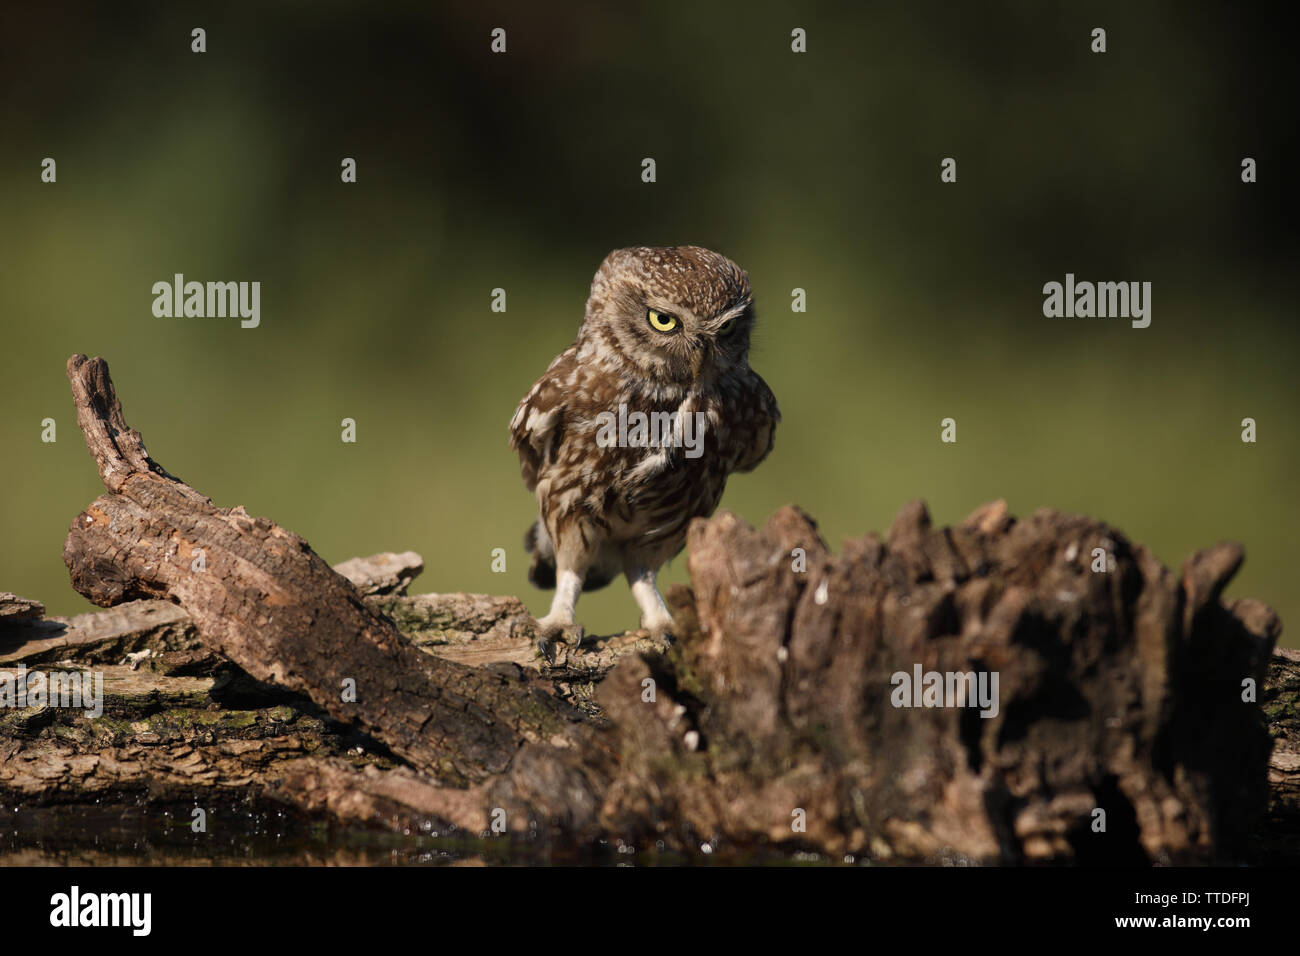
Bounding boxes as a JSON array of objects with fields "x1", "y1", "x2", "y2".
[{"x1": 64, "y1": 355, "x2": 582, "y2": 782}]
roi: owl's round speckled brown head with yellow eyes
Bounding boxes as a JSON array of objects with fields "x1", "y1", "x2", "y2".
[{"x1": 579, "y1": 246, "x2": 754, "y2": 385}]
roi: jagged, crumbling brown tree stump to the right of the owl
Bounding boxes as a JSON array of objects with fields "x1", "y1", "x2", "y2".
[{"x1": 475, "y1": 503, "x2": 1279, "y2": 862}]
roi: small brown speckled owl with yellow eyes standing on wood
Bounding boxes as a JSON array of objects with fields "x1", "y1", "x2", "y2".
[{"x1": 510, "y1": 246, "x2": 780, "y2": 649}]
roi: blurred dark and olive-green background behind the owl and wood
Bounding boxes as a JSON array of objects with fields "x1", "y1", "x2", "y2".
[{"x1": 0, "y1": 1, "x2": 1300, "y2": 646}]
